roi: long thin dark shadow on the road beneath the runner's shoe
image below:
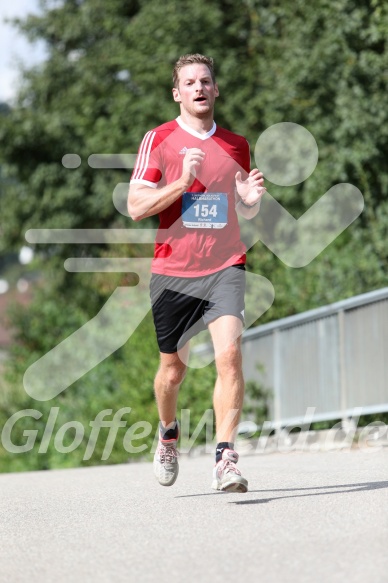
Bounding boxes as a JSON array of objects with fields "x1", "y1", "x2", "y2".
[{"x1": 175, "y1": 481, "x2": 388, "y2": 504}]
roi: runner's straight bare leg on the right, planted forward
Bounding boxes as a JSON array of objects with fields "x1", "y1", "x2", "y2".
[{"x1": 209, "y1": 316, "x2": 244, "y2": 443}]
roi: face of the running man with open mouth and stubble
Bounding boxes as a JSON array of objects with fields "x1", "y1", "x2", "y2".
[{"x1": 172, "y1": 63, "x2": 219, "y2": 117}]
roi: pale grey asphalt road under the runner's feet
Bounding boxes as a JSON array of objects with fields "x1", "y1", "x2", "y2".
[{"x1": 0, "y1": 448, "x2": 388, "y2": 583}]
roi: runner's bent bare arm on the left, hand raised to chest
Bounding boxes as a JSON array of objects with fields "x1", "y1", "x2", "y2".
[{"x1": 128, "y1": 148, "x2": 205, "y2": 221}]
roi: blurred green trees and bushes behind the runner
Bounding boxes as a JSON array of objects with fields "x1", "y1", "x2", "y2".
[{"x1": 0, "y1": 0, "x2": 388, "y2": 471}]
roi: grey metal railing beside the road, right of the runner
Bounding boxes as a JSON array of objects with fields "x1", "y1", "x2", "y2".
[{"x1": 242, "y1": 288, "x2": 388, "y2": 427}]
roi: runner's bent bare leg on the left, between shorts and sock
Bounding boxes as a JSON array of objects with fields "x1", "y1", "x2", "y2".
[{"x1": 154, "y1": 343, "x2": 189, "y2": 427}]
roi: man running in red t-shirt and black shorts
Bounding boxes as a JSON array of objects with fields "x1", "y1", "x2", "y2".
[{"x1": 128, "y1": 54, "x2": 265, "y2": 492}]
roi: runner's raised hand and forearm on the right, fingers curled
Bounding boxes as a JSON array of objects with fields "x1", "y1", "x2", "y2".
[{"x1": 235, "y1": 168, "x2": 267, "y2": 219}]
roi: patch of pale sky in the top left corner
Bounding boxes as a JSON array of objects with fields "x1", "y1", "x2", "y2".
[{"x1": 0, "y1": 0, "x2": 45, "y2": 103}]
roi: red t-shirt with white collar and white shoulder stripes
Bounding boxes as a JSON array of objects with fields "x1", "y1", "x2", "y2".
[{"x1": 131, "y1": 117, "x2": 250, "y2": 277}]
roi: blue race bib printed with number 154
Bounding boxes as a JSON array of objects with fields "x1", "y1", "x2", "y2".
[{"x1": 182, "y1": 192, "x2": 228, "y2": 229}]
